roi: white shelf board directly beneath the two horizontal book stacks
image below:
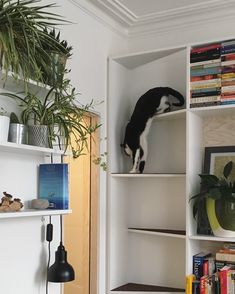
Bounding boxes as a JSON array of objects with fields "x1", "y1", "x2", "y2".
[{"x1": 190, "y1": 104, "x2": 235, "y2": 117}]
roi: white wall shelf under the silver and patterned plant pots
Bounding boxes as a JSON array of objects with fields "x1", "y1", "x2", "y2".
[{"x1": 0, "y1": 142, "x2": 64, "y2": 155}]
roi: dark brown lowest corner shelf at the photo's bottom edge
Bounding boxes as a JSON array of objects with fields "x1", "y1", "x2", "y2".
[{"x1": 112, "y1": 283, "x2": 185, "y2": 292}]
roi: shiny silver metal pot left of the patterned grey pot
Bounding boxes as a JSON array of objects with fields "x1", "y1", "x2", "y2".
[{"x1": 8, "y1": 123, "x2": 28, "y2": 144}]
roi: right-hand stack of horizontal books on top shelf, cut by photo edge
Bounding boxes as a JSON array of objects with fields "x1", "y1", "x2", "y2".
[{"x1": 221, "y1": 40, "x2": 235, "y2": 105}]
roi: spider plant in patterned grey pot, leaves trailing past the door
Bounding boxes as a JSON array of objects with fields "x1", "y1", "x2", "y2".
[{"x1": 1, "y1": 80, "x2": 99, "y2": 153}]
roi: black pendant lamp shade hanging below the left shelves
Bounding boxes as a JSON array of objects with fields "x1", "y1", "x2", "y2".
[{"x1": 47, "y1": 242, "x2": 75, "y2": 283}]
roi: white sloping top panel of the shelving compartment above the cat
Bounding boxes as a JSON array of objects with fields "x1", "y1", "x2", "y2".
[{"x1": 110, "y1": 47, "x2": 186, "y2": 69}]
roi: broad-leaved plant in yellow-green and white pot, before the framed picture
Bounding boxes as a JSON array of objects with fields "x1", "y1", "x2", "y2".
[{"x1": 190, "y1": 161, "x2": 235, "y2": 237}]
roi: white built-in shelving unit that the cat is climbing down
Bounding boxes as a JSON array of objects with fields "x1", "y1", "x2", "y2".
[{"x1": 107, "y1": 40, "x2": 235, "y2": 293}]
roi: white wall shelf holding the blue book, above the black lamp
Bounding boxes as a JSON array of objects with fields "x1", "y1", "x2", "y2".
[{"x1": 0, "y1": 209, "x2": 72, "y2": 219}]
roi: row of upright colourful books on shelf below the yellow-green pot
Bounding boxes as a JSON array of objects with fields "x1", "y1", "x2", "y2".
[{"x1": 186, "y1": 243, "x2": 235, "y2": 294}]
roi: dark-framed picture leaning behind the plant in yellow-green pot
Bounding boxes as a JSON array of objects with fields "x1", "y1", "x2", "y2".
[{"x1": 204, "y1": 146, "x2": 235, "y2": 178}]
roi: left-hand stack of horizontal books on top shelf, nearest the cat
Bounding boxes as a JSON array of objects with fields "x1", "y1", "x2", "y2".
[{"x1": 190, "y1": 43, "x2": 221, "y2": 107}]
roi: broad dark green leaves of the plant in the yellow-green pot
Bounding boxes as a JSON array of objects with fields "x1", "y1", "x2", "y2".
[{"x1": 190, "y1": 161, "x2": 235, "y2": 217}]
